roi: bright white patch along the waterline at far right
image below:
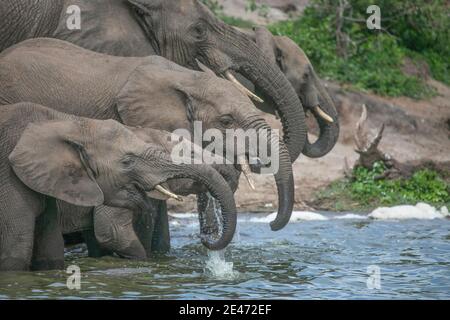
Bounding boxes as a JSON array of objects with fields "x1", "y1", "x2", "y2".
[{"x1": 369, "y1": 202, "x2": 449, "y2": 220}]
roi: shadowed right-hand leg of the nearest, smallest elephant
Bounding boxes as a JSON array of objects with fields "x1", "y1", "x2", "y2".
[{"x1": 31, "y1": 198, "x2": 64, "y2": 270}]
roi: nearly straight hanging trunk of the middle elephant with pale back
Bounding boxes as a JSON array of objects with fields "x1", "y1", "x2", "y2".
[{"x1": 244, "y1": 120, "x2": 294, "y2": 231}]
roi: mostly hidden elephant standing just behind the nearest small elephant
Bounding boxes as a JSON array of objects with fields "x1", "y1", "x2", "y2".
[{"x1": 64, "y1": 135, "x2": 240, "y2": 259}]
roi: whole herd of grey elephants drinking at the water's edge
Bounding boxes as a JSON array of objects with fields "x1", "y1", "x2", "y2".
[{"x1": 0, "y1": 0, "x2": 339, "y2": 271}]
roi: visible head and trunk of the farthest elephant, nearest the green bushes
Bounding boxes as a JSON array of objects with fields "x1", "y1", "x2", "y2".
[{"x1": 237, "y1": 27, "x2": 339, "y2": 158}]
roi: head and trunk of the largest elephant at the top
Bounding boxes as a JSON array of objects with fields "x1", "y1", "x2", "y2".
[{"x1": 128, "y1": 0, "x2": 306, "y2": 160}]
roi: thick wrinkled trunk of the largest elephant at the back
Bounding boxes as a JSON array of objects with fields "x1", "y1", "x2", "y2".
[{"x1": 219, "y1": 26, "x2": 307, "y2": 162}]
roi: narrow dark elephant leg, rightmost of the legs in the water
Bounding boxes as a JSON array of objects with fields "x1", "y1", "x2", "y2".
[{"x1": 152, "y1": 200, "x2": 170, "y2": 253}]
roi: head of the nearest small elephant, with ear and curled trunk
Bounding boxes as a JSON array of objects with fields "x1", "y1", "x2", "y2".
[{"x1": 9, "y1": 118, "x2": 236, "y2": 250}]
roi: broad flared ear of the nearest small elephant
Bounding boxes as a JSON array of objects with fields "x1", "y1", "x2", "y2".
[{"x1": 9, "y1": 121, "x2": 104, "y2": 207}]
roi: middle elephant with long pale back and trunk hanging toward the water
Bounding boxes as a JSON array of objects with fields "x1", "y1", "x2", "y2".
[{"x1": 0, "y1": 39, "x2": 294, "y2": 230}]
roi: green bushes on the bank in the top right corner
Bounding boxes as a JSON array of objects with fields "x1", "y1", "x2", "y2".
[{"x1": 270, "y1": 0, "x2": 450, "y2": 99}]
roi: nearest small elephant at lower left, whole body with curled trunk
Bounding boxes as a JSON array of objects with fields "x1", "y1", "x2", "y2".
[{"x1": 0, "y1": 102, "x2": 236, "y2": 271}]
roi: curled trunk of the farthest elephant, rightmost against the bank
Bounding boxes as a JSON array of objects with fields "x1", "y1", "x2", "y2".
[{"x1": 303, "y1": 70, "x2": 339, "y2": 158}]
